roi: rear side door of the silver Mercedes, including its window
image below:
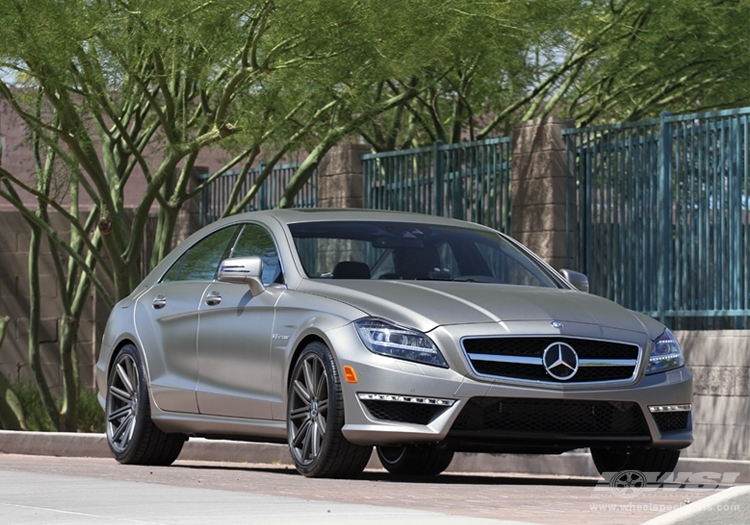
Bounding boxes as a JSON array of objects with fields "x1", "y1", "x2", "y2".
[{"x1": 135, "y1": 226, "x2": 237, "y2": 413}]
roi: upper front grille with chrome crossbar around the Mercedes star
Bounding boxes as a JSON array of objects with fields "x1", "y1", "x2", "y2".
[{"x1": 461, "y1": 337, "x2": 641, "y2": 383}]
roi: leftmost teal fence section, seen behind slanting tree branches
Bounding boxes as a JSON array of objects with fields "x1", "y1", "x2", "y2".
[{"x1": 199, "y1": 163, "x2": 318, "y2": 226}]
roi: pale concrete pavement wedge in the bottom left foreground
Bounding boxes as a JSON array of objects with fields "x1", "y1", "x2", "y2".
[{"x1": 0, "y1": 471, "x2": 534, "y2": 525}]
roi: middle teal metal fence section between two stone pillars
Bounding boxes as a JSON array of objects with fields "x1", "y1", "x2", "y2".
[{"x1": 362, "y1": 138, "x2": 510, "y2": 233}]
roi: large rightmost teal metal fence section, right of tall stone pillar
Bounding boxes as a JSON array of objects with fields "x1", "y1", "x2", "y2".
[{"x1": 563, "y1": 108, "x2": 750, "y2": 329}]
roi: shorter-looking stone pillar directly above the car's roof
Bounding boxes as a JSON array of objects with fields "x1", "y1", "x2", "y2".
[{"x1": 318, "y1": 144, "x2": 370, "y2": 208}]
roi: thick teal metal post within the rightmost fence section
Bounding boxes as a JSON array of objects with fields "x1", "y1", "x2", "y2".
[{"x1": 657, "y1": 111, "x2": 672, "y2": 324}]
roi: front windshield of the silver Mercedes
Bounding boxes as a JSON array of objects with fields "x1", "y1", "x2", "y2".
[{"x1": 289, "y1": 221, "x2": 559, "y2": 288}]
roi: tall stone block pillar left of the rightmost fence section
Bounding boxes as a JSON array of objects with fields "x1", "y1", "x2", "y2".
[{"x1": 511, "y1": 117, "x2": 575, "y2": 269}]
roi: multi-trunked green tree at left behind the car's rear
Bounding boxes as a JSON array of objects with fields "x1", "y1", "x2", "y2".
[{"x1": 0, "y1": 0, "x2": 488, "y2": 430}]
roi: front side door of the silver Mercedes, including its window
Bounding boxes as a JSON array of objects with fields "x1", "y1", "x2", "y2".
[{"x1": 197, "y1": 223, "x2": 286, "y2": 419}]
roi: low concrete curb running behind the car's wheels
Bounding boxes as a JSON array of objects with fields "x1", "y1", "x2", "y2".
[{"x1": 0, "y1": 430, "x2": 750, "y2": 483}]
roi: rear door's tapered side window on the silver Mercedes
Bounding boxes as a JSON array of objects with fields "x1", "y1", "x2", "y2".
[{"x1": 163, "y1": 226, "x2": 237, "y2": 282}]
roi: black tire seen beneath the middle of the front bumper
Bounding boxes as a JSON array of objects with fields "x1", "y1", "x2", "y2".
[{"x1": 377, "y1": 445, "x2": 453, "y2": 476}]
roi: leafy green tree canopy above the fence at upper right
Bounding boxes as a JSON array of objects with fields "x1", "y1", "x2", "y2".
[{"x1": 359, "y1": 0, "x2": 750, "y2": 151}]
